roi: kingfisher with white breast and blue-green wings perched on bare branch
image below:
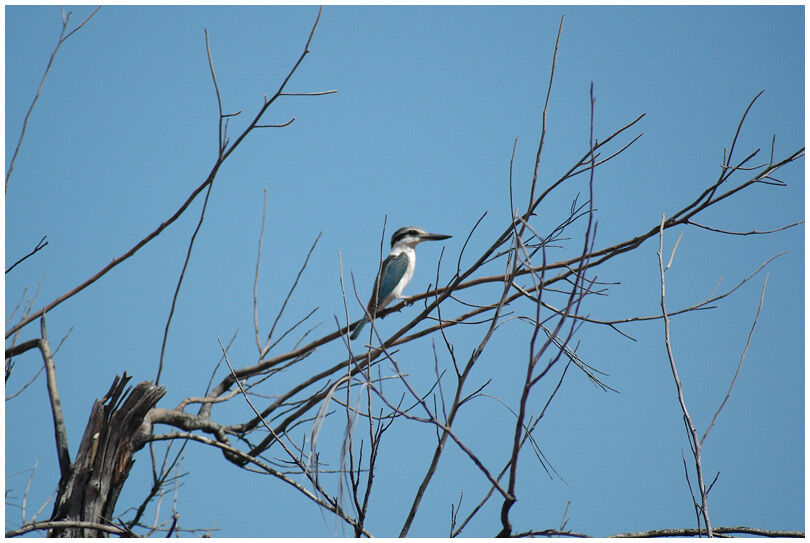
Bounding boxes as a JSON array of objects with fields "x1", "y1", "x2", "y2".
[{"x1": 351, "y1": 226, "x2": 452, "y2": 339}]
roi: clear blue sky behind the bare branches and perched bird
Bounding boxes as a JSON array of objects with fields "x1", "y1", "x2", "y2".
[{"x1": 5, "y1": 6, "x2": 805, "y2": 537}]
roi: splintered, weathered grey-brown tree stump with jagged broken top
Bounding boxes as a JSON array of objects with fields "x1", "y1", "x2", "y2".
[{"x1": 48, "y1": 372, "x2": 166, "y2": 537}]
